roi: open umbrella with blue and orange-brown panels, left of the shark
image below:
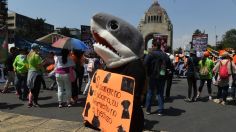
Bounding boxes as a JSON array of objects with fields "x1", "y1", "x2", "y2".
[{"x1": 52, "y1": 37, "x2": 89, "y2": 51}]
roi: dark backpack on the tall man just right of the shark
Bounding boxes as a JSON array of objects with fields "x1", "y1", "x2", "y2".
[{"x1": 151, "y1": 53, "x2": 167, "y2": 79}]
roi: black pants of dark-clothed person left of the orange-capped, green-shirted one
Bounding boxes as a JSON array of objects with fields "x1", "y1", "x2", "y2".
[{"x1": 187, "y1": 76, "x2": 197, "y2": 99}]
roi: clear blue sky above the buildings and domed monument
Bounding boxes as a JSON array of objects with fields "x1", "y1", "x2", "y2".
[{"x1": 8, "y1": 0, "x2": 236, "y2": 49}]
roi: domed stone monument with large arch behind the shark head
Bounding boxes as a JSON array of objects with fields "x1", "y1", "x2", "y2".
[{"x1": 138, "y1": 1, "x2": 173, "y2": 49}]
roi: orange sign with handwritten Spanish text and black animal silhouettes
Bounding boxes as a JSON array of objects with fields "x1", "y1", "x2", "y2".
[{"x1": 83, "y1": 70, "x2": 135, "y2": 132}]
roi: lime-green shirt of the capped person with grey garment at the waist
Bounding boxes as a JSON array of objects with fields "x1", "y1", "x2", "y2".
[{"x1": 27, "y1": 51, "x2": 43, "y2": 72}]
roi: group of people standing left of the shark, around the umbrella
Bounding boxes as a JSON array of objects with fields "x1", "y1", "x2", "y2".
[{"x1": 0, "y1": 43, "x2": 102, "y2": 108}]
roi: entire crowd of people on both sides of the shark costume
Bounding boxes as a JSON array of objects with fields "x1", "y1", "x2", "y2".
[{"x1": 1, "y1": 42, "x2": 236, "y2": 122}]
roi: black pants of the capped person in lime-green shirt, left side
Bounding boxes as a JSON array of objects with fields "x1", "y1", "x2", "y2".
[{"x1": 31, "y1": 75, "x2": 43, "y2": 104}]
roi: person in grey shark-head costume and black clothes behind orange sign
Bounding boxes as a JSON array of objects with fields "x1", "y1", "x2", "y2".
[{"x1": 91, "y1": 13, "x2": 146, "y2": 132}]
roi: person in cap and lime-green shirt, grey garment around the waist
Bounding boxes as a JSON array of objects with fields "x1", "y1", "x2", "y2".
[{"x1": 27, "y1": 43, "x2": 44, "y2": 107}]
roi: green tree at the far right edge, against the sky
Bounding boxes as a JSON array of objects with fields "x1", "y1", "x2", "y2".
[{"x1": 220, "y1": 29, "x2": 236, "y2": 49}]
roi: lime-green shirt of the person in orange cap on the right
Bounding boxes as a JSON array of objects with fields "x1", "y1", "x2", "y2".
[{"x1": 198, "y1": 58, "x2": 214, "y2": 79}]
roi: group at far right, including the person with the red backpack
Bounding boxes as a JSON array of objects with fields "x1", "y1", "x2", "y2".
[{"x1": 186, "y1": 51, "x2": 236, "y2": 105}]
